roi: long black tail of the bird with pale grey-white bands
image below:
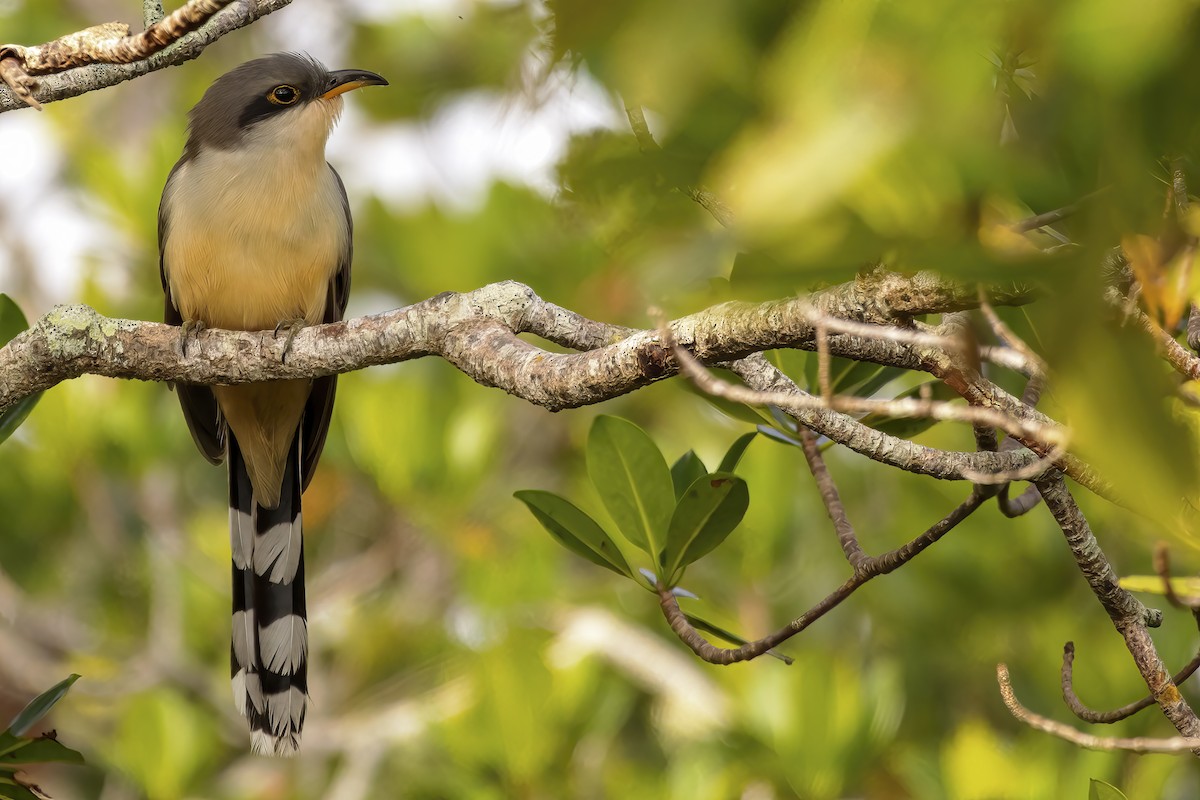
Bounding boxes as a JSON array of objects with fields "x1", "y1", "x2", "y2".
[{"x1": 229, "y1": 432, "x2": 308, "y2": 756}]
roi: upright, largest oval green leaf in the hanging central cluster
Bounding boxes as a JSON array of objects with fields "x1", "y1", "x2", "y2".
[{"x1": 588, "y1": 415, "x2": 674, "y2": 564}]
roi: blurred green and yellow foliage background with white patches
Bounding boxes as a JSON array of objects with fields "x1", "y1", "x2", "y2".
[{"x1": 0, "y1": 0, "x2": 1200, "y2": 800}]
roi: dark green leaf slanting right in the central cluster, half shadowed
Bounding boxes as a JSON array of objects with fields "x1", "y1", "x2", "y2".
[{"x1": 662, "y1": 473, "x2": 750, "y2": 584}]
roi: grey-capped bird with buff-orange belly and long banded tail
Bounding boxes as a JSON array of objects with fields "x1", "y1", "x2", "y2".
[{"x1": 158, "y1": 53, "x2": 388, "y2": 756}]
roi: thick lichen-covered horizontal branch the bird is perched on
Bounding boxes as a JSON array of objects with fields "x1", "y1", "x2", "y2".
[{"x1": 0, "y1": 276, "x2": 1045, "y2": 489}]
